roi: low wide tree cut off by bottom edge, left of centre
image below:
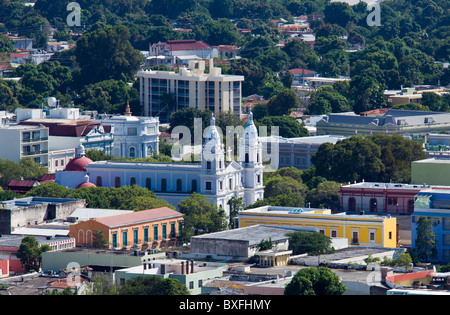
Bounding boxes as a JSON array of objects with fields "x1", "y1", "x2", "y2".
[{"x1": 119, "y1": 276, "x2": 190, "y2": 295}]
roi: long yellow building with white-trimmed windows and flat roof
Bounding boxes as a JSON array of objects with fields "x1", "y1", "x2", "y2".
[{"x1": 239, "y1": 206, "x2": 397, "y2": 248}]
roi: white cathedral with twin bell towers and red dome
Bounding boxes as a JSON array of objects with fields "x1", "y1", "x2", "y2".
[{"x1": 56, "y1": 112, "x2": 264, "y2": 215}]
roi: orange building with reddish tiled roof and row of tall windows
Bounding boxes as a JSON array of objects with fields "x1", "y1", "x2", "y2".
[{"x1": 69, "y1": 207, "x2": 183, "y2": 250}]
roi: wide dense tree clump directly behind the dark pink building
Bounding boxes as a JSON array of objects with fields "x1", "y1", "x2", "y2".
[{"x1": 311, "y1": 134, "x2": 426, "y2": 183}]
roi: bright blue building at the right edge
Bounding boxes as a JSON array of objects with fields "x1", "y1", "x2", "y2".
[{"x1": 411, "y1": 188, "x2": 450, "y2": 263}]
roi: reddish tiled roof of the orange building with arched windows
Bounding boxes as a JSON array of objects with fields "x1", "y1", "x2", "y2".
[{"x1": 94, "y1": 207, "x2": 183, "y2": 227}]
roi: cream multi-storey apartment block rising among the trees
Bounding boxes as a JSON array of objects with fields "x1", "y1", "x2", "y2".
[{"x1": 137, "y1": 59, "x2": 244, "y2": 122}]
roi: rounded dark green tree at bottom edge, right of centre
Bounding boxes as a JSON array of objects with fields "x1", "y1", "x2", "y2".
[{"x1": 284, "y1": 267, "x2": 347, "y2": 295}]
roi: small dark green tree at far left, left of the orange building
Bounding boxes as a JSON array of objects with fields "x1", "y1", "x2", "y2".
[{"x1": 17, "y1": 236, "x2": 50, "y2": 272}]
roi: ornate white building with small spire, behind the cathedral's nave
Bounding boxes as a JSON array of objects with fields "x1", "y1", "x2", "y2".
[{"x1": 102, "y1": 104, "x2": 159, "y2": 158}]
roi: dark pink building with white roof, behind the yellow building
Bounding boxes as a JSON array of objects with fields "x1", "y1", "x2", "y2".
[{"x1": 340, "y1": 182, "x2": 425, "y2": 214}]
